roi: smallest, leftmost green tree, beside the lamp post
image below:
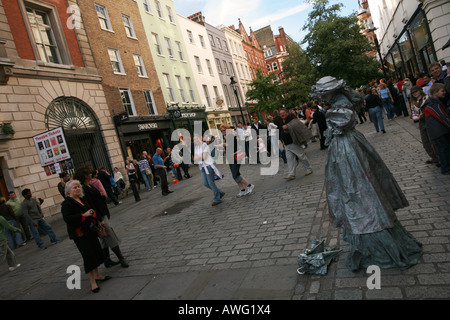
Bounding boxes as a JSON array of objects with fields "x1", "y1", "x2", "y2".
[{"x1": 246, "y1": 69, "x2": 280, "y2": 113}]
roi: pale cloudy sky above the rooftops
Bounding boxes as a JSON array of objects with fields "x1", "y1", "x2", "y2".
[{"x1": 174, "y1": 0, "x2": 358, "y2": 42}]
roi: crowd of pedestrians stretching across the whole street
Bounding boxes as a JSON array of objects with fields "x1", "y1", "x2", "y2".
[{"x1": 0, "y1": 57, "x2": 450, "y2": 293}]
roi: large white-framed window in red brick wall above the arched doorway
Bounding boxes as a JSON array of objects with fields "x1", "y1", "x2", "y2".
[{"x1": 26, "y1": 7, "x2": 63, "y2": 64}]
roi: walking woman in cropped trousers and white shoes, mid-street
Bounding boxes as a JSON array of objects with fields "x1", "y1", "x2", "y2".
[{"x1": 220, "y1": 124, "x2": 255, "y2": 198}]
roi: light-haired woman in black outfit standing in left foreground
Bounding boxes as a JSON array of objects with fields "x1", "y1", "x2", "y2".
[{"x1": 61, "y1": 180, "x2": 110, "y2": 293}]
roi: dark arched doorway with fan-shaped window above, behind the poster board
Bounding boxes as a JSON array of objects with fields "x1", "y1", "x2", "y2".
[{"x1": 45, "y1": 97, "x2": 112, "y2": 173}]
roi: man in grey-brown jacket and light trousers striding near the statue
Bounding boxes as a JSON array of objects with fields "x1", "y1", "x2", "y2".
[{"x1": 280, "y1": 108, "x2": 312, "y2": 180}]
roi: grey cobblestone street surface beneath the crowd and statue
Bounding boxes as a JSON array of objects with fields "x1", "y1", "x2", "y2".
[{"x1": 0, "y1": 117, "x2": 450, "y2": 300}]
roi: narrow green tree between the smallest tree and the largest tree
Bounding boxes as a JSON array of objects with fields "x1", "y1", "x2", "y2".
[{"x1": 280, "y1": 44, "x2": 316, "y2": 108}]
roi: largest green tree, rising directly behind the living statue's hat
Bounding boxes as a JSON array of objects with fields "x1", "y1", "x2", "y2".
[{"x1": 302, "y1": 0, "x2": 380, "y2": 87}]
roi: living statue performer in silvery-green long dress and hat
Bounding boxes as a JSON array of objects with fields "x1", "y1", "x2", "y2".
[{"x1": 312, "y1": 76, "x2": 422, "y2": 271}]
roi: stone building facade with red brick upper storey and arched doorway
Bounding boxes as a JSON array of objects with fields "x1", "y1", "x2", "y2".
[{"x1": 0, "y1": 0, "x2": 123, "y2": 217}]
